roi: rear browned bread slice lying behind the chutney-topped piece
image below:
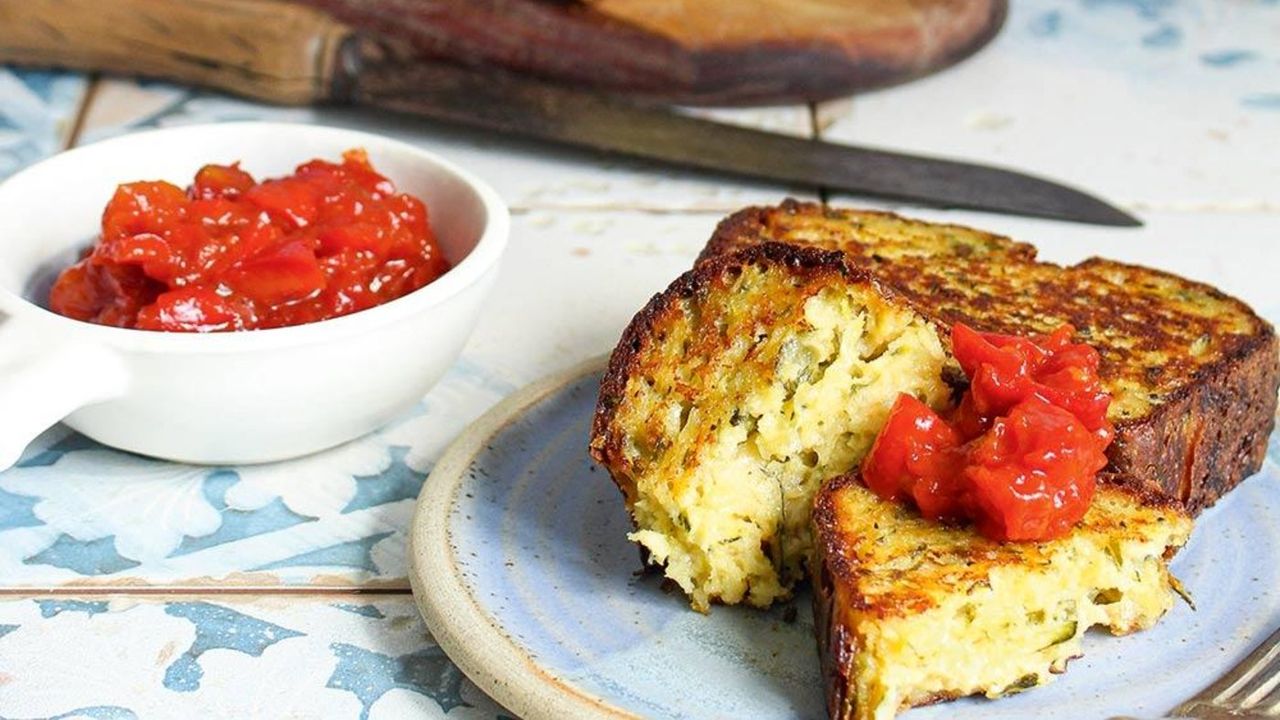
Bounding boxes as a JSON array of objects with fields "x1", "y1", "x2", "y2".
[{"x1": 698, "y1": 200, "x2": 1280, "y2": 515}]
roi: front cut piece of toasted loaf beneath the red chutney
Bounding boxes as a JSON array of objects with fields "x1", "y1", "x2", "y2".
[{"x1": 812, "y1": 474, "x2": 1192, "y2": 720}]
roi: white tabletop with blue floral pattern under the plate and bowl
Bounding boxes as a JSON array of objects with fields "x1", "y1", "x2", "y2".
[{"x1": 0, "y1": 0, "x2": 1280, "y2": 720}]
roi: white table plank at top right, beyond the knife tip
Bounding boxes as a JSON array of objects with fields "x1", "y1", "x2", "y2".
[{"x1": 819, "y1": 0, "x2": 1280, "y2": 211}]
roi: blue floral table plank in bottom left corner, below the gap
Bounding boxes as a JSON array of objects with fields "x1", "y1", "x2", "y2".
[{"x1": 0, "y1": 596, "x2": 508, "y2": 720}]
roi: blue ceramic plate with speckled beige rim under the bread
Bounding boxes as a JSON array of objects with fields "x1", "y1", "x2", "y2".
[{"x1": 411, "y1": 360, "x2": 1280, "y2": 720}]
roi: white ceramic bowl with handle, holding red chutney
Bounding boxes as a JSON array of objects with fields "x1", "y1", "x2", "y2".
[{"x1": 0, "y1": 123, "x2": 509, "y2": 469}]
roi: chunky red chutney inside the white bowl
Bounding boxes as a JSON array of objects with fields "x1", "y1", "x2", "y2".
[{"x1": 49, "y1": 150, "x2": 448, "y2": 332}]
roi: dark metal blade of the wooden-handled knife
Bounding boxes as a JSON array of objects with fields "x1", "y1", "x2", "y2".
[{"x1": 348, "y1": 38, "x2": 1142, "y2": 227}]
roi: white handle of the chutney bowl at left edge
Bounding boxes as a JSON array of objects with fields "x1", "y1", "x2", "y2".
[{"x1": 0, "y1": 316, "x2": 129, "y2": 470}]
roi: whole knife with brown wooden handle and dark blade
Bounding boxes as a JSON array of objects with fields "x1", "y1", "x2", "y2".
[{"x1": 0, "y1": 0, "x2": 1142, "y2": 227}]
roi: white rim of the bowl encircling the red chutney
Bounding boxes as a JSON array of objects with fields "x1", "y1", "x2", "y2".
[{"x1": 0, "y1": 120, "x2": 511, "y2": 354}]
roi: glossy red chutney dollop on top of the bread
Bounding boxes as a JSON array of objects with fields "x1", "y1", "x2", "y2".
[{"x1": 861, "y1": 324, "x2": 1115, "y2": 541}]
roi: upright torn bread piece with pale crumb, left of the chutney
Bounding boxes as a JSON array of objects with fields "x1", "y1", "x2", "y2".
[{"x1": 590, "y1": 243, "x2": 951, "y2": 610}]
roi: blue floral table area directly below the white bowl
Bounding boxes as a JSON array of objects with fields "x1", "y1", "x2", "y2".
[{"x1": 0, "y1": 364, "x2": 508, "y2": 587}]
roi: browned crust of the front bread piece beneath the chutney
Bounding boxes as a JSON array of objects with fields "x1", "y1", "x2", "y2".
[{"x1": 810, "y1": 471, "x2": 1192, "y2": 720}]
